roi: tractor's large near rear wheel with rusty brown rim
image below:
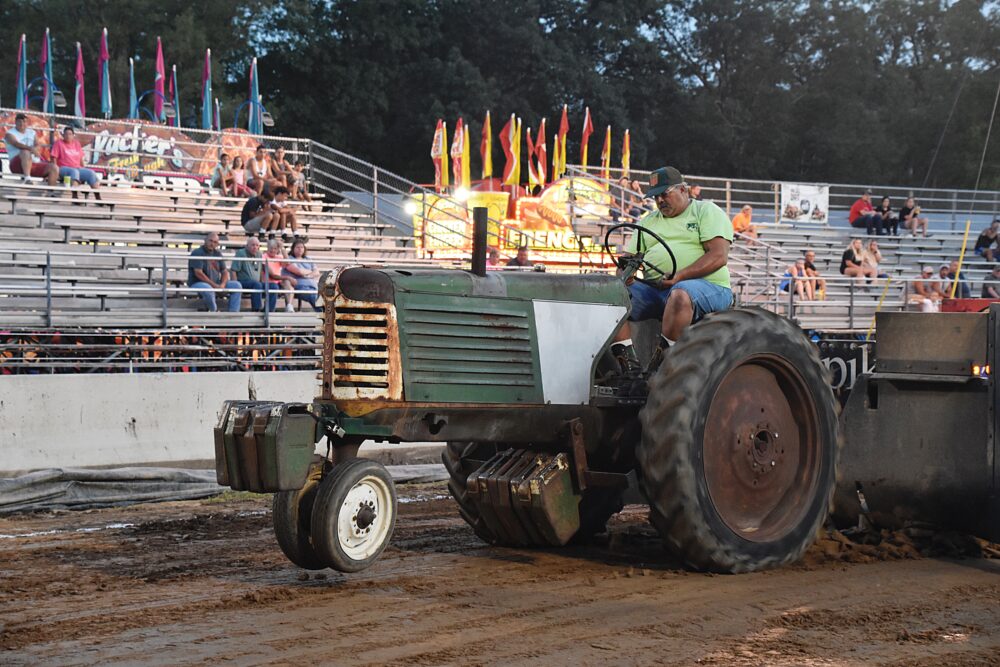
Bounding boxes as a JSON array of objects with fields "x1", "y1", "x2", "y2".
[{"x1": 636, "y1": 308, "x2": 839, "y2": 572}]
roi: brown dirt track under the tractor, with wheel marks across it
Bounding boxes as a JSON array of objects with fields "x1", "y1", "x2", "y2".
[{"x1": 0, "y1": 486, "x2": 1000, "y2": 665}]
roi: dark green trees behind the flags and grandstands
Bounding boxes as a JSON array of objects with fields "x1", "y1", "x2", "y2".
[{"x1": 0, "y1": 0, "x2": 1000, "y2": 187}]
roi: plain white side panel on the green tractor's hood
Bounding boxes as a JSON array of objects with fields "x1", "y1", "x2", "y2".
[{"x1": 532, "y1": 301, "x2": 626, "y2": 405}]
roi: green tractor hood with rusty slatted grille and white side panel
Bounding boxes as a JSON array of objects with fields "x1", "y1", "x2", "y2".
[{"x1": 319, "y1": 268, "x2": 629, "y2": 415}]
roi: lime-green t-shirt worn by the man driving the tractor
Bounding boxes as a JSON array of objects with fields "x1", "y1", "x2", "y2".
[{"x1": 625, "y1": 199, "x2": 733, "y2": 287}]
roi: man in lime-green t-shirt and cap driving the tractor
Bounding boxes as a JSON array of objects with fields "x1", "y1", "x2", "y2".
[{"x1": 611, "y1": 167, "x2": 733, "y2": 392}]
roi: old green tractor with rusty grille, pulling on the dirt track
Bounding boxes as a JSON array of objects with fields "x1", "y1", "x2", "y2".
[{"x1": 215, "y1": 224, "x2": 838, "y2": 572}]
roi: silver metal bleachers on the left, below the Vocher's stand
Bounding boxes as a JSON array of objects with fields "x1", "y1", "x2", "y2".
[{"x1": 0, "y1": 176, "x2": 454, "y2": 329}]
